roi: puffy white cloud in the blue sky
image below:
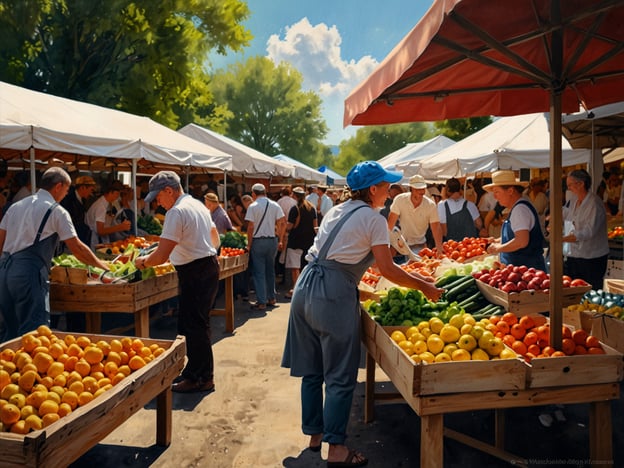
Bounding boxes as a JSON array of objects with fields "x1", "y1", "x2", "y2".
[{"x1": 267, "y1": 18, "x2": 377, "y2": 144}]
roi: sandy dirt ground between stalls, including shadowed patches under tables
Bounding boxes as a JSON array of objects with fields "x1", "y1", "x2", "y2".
[{"x1": 71, "y1": 282, "x2": 624, "y2": 468}]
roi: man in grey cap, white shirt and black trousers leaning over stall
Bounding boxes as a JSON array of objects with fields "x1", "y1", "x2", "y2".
[{"x1": 135, "y1": 171, "x2": 219, "y2": 393}]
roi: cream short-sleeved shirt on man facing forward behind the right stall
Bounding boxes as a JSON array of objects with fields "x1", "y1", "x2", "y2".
[{"x1": 390, "y1": 192, "x2": 440, "y2": 245}]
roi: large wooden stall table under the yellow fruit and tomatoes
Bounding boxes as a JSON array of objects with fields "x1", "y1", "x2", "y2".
[{"x1": 362, "y1": 311, "x2": 622, "y2": 468}]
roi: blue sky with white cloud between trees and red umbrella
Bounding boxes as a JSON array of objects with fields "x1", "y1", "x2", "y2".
[{"x1": 211, "y1": 0, "x2": 432, "y2": 144}]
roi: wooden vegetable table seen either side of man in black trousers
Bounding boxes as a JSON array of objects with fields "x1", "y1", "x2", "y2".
[{"x1": 50, "y1": 254, "x2": 249, "y2": 337}]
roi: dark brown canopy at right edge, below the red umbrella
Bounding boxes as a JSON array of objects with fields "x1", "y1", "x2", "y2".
[{"x1": 561, "y1": 102, "x2": 624, "y2": 149}]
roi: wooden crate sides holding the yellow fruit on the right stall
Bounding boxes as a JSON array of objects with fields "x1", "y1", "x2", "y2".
[{"x1": 361, "y1": 310, "x2": 528, "y2": 399}]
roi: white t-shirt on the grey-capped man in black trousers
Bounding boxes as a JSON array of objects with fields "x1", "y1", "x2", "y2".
[{"x1": 160, "y1": 194, "x2": 217, "y2": 265}]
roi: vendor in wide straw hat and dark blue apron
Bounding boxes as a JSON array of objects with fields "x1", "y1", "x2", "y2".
[{"x1": 483, "y1": 170, "x2": 546, "y2": 270}]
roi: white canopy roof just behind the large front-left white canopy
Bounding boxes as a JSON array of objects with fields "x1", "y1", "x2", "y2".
[{"x1": 178, "y1": 124, "x2": 295, "y2": 177}]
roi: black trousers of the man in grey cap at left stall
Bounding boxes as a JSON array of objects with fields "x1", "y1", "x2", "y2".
[{"x1": 176, "y1": 256, "x2": 219, "y2": 383}]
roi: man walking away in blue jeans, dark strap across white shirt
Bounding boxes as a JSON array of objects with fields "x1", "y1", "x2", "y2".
[{"x1": 245, "y1": 184, "x2": 286, "y2": 310}]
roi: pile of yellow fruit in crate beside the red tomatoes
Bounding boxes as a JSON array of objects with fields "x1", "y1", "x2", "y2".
[{"x1": 390, "y1": 313, "x2": 518, "y2": 364}]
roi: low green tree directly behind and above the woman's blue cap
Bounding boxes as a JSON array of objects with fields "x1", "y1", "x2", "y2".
[{"x1": 335, "y1": 122, "x2": 432, "y2": 173}]
